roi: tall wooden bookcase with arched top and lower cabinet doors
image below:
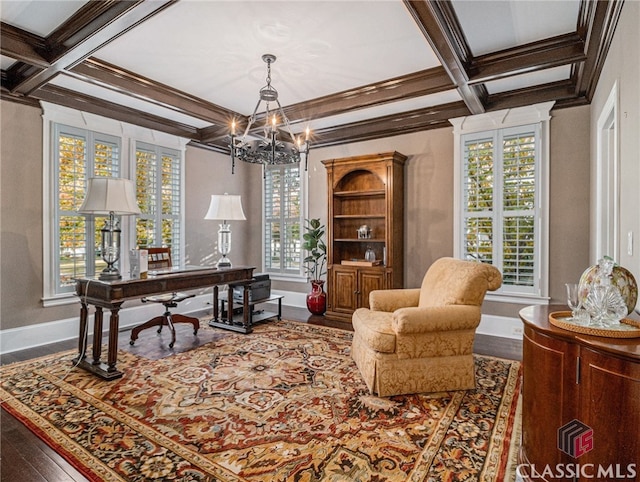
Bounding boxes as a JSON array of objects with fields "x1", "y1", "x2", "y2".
[{"x1": 322, "y1": 152, "x2": 407, "y2": 321}]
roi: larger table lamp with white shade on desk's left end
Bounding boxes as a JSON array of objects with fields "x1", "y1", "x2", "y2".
[{"x1": 78, "y1": 177, "x2": 140, "y2": 281}]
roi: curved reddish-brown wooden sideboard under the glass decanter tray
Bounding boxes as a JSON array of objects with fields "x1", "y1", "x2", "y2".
[{"x1": 518, "y1": 306, "x2": 640, "y2": 481}]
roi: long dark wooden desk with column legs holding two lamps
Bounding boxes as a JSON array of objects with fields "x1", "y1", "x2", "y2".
[{"x1": 74, "y1": 266, "x2": 255, "y2": 380}]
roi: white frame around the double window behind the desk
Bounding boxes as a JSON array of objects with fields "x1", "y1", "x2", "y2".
[{"x1": 41, "y1": 102, "x2": 189, "y2": 307}]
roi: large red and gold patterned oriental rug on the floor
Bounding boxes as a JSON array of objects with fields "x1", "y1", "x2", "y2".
[{"x1": 0, "y1": 321, "x2": 520, "y2": 482}]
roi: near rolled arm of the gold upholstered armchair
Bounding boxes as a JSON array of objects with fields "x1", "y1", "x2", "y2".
[{"x1": 391, "y1": 305, "x2": 481, "y2": 334}]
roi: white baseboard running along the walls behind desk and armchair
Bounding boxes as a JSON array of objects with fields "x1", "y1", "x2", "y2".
[{"x1": 0, "y1": 290, "x2": 522, "y2": 353}]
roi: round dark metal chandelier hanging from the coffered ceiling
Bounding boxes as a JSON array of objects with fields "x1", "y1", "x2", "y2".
[{"x1": 229, "y1": 54, "x2": 309, "y2": 174}]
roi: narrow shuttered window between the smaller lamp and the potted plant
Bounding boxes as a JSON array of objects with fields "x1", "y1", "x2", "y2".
[{"x1": 263, "y1": 164, "x2": 304, "y2": 277}]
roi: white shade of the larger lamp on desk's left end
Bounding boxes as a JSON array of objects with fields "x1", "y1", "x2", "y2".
[{"x1": 78, "y1": 177, "x2": 140, "y2": 214}]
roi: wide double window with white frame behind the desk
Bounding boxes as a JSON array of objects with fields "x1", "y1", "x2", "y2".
[{"x1": 42, "y1": 102, "x2": 187, "y2": 306}]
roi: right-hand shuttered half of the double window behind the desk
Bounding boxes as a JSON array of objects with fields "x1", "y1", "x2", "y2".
[{"x1": 135, "y1": 142, "x2": 182, "y2": 266}]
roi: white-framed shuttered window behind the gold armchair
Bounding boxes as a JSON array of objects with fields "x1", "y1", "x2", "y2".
[{"x1": 452, "y1": 104, "x2": 552, "y2": 301}]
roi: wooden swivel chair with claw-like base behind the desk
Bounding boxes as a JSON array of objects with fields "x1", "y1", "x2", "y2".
[{"x1": 129, "y1": 248, "x2": 200, "y2": 348}]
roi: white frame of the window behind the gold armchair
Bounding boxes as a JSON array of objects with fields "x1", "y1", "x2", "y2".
[{"x1": 449, "y1": 102, "x2": 554, "y2": 304}]
